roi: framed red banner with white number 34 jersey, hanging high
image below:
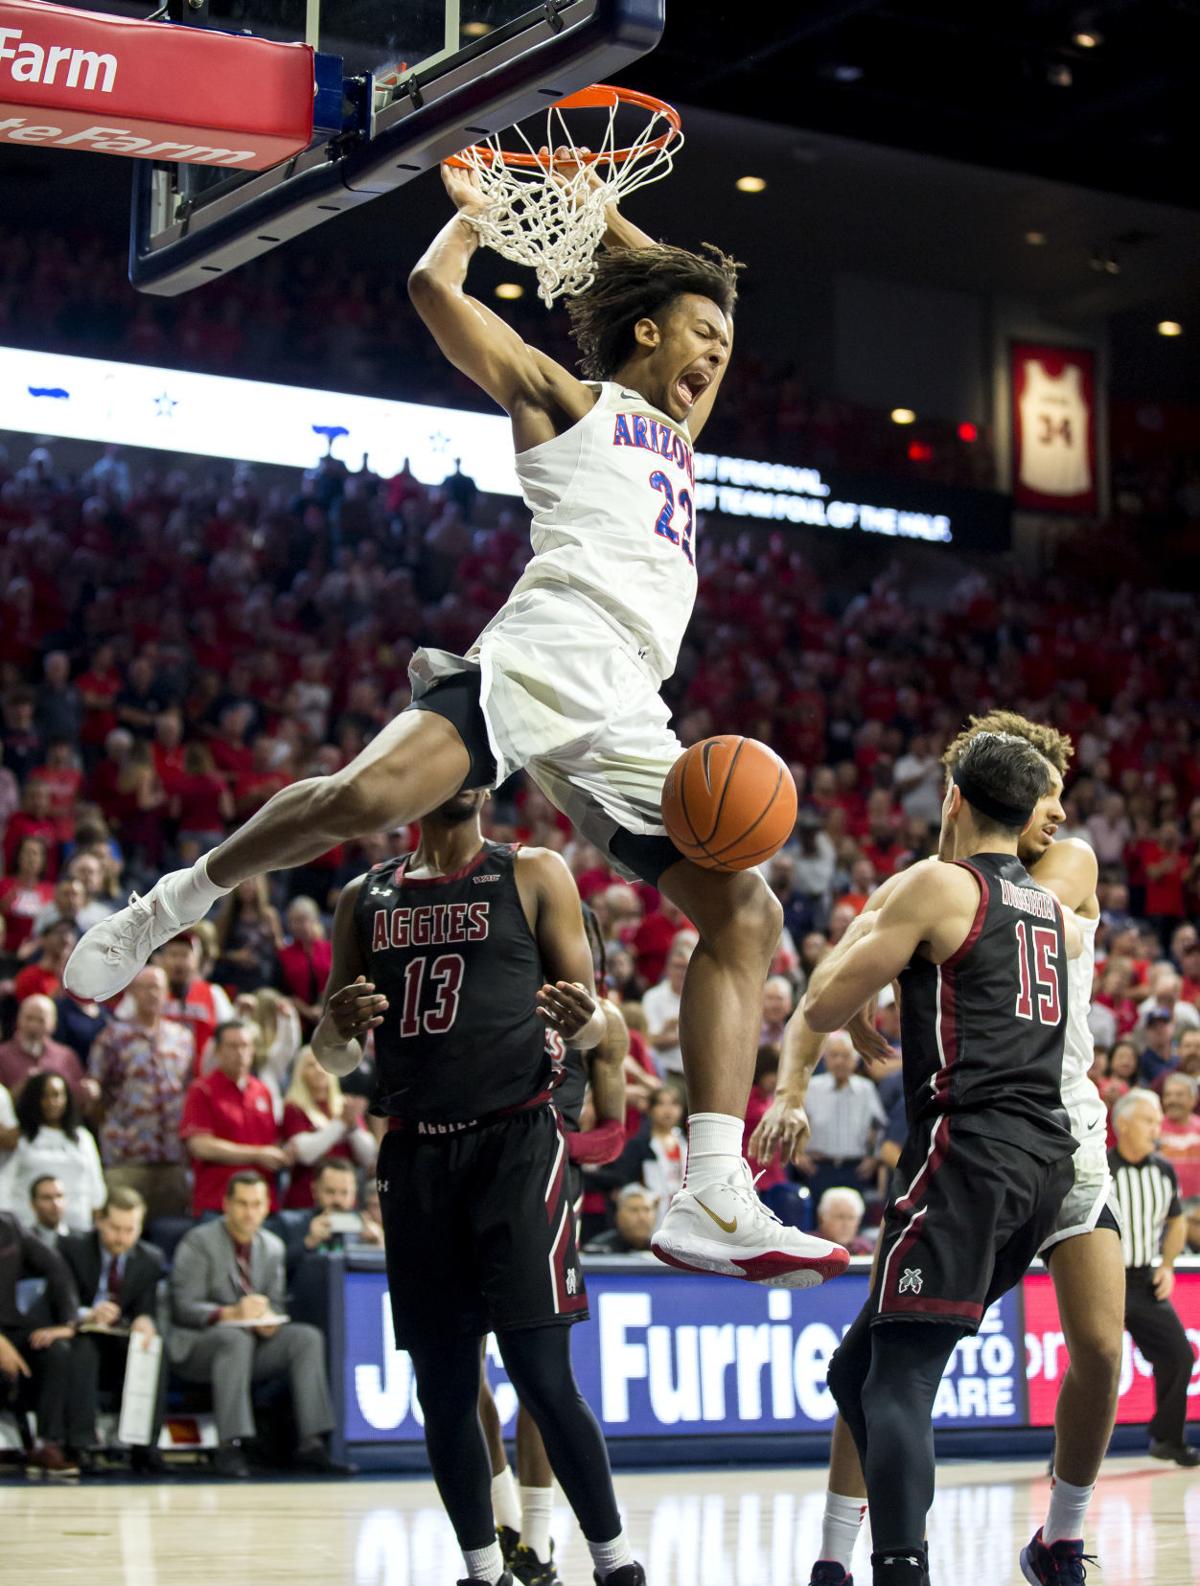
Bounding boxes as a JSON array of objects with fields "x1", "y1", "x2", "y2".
[{"x1": 1011, "y1": 344, "x2": 1099, "y2": 514}]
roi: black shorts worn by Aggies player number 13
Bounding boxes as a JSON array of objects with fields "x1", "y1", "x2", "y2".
[{"x1": 376, "y1": 1102, "x2": 588, "y2": 1348}]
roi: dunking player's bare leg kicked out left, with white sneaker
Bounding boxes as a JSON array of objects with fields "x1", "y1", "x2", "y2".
[{"x1": 63, "y1": 711, "x2": 471, "y2": 1001}]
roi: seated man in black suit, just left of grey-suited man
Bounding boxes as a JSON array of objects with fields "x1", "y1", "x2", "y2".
[{"x1": 59, "y1": 1188, "x2": 166, "y2": 1472}]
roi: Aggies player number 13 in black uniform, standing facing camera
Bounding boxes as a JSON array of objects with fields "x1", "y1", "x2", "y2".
[{"x1": 312, "y1": 793, "x2": 645, "y2": 1586}]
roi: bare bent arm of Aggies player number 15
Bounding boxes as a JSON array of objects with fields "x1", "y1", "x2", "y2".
[{"x1": 804, "y1": 864, "x2": 980, "y2": 1031}]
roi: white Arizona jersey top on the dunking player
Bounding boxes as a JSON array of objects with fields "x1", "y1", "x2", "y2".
[{"x1": 490, "y1": 381, "x2": 696, "y2": 682}]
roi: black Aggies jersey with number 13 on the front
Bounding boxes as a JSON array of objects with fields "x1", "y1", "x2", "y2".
[{"x1": 354, "y1": 842, "x2": 552, "y2": 1123}]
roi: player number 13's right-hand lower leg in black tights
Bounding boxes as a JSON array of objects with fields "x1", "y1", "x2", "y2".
[{"x1": 496, "y1": 1326, "x2": 645, "y2": 1586}]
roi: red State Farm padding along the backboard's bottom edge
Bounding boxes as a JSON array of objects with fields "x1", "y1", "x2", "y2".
[{"x1": 0, "y1": 0, "x2": 314, "y2": 171}]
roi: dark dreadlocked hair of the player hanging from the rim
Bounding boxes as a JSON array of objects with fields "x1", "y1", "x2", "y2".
[{"x1": 566, "y1": 243, "x2": 742, "y2": 381}]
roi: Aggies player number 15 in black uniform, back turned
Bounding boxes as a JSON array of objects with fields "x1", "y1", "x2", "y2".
[{"x1": 805, "y1": 733, "x2": 1083, "y2": 1586}]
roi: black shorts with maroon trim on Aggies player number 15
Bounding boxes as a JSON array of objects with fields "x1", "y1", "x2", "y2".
[{"x1": 870, "y1": 1113, "x2": 1075, "y2": 1332}]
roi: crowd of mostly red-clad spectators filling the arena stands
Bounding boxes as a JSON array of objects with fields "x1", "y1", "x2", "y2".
[{"x1": 0, "y1": 442, "x2": 1200, "y2": 1477}]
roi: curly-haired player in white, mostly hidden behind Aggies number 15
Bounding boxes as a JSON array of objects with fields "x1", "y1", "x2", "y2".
[{"x1": 751, "y1": 711, "x2": 1125, "y2": 1586}]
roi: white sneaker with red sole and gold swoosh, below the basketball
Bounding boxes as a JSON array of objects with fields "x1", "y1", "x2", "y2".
[{"x1": 650, "y1": 1161, "x2": 850, "y2": 1288}]
